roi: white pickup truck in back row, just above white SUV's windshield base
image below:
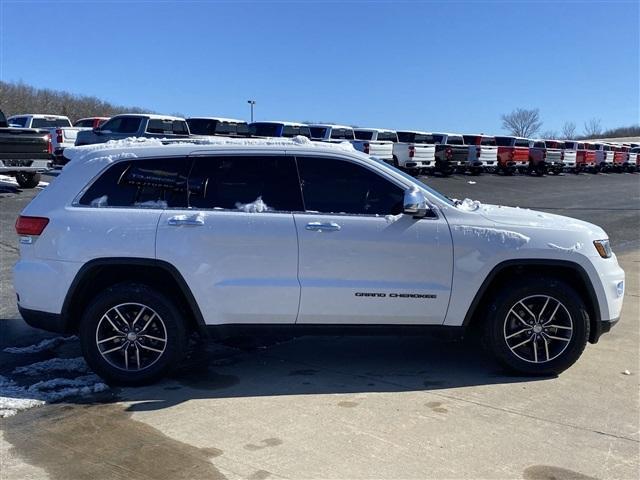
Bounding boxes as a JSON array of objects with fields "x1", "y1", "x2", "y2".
[{"x1": 393, "y1": 130, "x2": 436, "y2": 173}]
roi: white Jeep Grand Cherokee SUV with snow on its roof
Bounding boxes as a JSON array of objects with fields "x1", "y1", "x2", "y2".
[{"x1": 14, "y1": 137, "x2": 624, "y2": 384}]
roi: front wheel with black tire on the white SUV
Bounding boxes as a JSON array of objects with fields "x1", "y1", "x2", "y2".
[{"x1": 484, "y1": 277, "x2": 589, "y2": 375}]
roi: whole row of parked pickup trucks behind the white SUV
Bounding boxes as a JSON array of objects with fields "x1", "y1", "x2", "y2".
[{"x1": 0, "y1": 114, "x2": 640, "y2": 188}]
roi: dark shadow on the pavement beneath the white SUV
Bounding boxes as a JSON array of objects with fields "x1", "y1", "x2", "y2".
[{"x1": 116, "y1": 336, "x2": 551, "y2": 412}]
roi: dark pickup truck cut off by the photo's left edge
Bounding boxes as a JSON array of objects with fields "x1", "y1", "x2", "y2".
[{"x1": 0, "y1": 111, "x2": 53, "y2": 188}]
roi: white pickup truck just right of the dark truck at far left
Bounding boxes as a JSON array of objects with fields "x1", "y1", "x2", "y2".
[{"x1": 7, "y1": 113, "x2": 90, "y2": 166}]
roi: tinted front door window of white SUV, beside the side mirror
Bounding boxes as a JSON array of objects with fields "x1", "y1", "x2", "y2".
[{"x1": 298, "y1": 157, "x2": 404, "y2": 215}]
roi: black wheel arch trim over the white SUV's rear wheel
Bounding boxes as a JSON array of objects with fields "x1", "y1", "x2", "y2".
[{"x1": 61, "y1": 257, "x2": 206, "y2": 335}]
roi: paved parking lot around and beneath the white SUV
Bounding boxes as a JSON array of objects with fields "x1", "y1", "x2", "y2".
[{"x1": 0, "y1": 174, "x2": 640, "y2": 480}]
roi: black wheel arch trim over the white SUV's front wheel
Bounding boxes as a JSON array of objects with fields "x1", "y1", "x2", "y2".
[{"x1": 462, "y1": 259, "x2": 602, "y2": 343}]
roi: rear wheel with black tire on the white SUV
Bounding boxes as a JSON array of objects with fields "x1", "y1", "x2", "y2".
[{"x1": 80, "y1": 283, "x2": 187, "y2": 386}]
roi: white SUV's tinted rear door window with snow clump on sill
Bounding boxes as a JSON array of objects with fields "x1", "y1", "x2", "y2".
[{"x1": 189, "y1": 156, "x2": 303, "y2": 212}]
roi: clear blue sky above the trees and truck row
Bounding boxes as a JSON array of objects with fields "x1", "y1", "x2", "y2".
[{"x1": 0, "y1": 0, "x2": 640, "y2": 133}]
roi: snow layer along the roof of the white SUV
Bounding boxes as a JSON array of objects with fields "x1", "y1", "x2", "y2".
[{"x1": 64, "y1": 136, "x2": 358, "y2": 161}]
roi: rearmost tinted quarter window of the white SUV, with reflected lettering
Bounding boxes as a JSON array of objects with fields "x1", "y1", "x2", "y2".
[{"x1": 80, "y1": 157, "x2": 190, "y2": 208}]
